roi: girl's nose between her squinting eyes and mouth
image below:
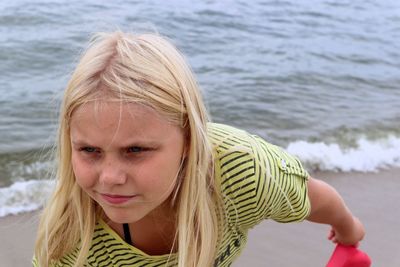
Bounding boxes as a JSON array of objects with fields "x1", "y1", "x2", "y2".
[{"x1": 99, "y1": 158, "x2": 127, "y2": 185}]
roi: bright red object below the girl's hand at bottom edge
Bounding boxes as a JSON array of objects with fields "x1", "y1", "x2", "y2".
[{"x1": 326, "y1": 245, "x2": 371, "y2": 267}]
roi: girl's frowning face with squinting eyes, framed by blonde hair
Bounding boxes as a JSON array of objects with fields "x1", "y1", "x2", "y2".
[{"x1": 70, "y1": 102, "x2": 185, "y2": 223}]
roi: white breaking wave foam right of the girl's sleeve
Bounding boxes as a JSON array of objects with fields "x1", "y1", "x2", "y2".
[{"x1": 287, "y1": 136, "x2": 400, "y2": 172}]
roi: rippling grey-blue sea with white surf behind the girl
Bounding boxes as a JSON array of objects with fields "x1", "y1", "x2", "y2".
[{"x1": 0, "y1": 0, "x2": 400, "y2": 217}]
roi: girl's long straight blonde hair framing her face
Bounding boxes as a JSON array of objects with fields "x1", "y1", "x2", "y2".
[{"x1": 35, "y1": 31, "x2": 222, "y2": 267}]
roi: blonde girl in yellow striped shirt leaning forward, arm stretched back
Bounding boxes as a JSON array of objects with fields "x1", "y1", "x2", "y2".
[{"x1": 33, "y1": 32, "x2": 364, "y2": 267}]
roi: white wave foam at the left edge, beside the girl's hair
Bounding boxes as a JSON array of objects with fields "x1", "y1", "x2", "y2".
[{"x1": 0, "y1": 180, "x2": 54, "y2": 217}]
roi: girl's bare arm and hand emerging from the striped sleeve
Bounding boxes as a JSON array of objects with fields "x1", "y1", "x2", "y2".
[{"x1": 307, "y1": 177, "x2": 365, "y2": 245}]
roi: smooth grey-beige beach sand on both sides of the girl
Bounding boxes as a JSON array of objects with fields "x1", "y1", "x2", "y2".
[{"x1": 0, "y1": 169, "x2": 400, "y2": 267}]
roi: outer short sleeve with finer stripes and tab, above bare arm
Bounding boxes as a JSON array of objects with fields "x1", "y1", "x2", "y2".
[{"x1": 253, "y1": 136, "x2": 310, "y2": 223}]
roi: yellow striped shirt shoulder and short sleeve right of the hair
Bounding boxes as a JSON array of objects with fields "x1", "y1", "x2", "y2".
[{"x1": 212, "y1": 123, "x2": 310, "y2": 228}]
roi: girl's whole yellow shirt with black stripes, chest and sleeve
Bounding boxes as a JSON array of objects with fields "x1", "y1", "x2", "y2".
[{"x1": 33, "y1": 123, "x2": 310, "y2": 267}]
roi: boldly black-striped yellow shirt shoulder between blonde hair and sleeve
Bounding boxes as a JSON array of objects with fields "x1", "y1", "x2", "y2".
[{"x1": 208, "y1": 123, "x2": 259, "y2": 226}]
